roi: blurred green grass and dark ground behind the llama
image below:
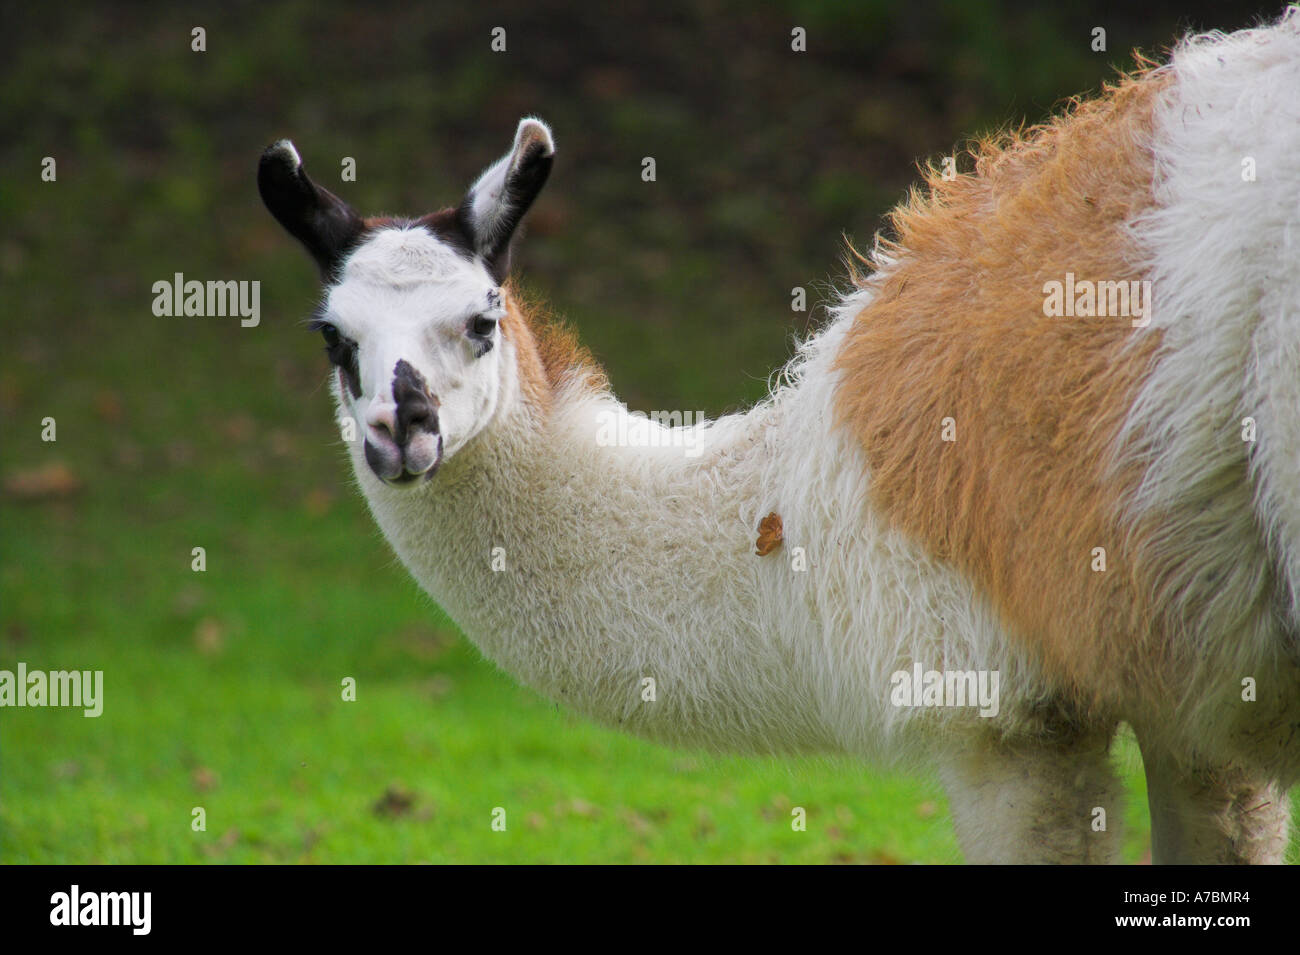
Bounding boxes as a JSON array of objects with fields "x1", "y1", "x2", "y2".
[{"x1": 0, "y1": 0, "x2": 1295, "y2": 863}]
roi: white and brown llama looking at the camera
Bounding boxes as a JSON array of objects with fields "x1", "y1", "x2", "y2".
[{"x1": 257, "y1": 12, "x2": 1300, "y2": 863}]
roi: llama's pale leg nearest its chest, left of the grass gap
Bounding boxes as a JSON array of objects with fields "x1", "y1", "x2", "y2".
[{"x1": 940, "y1": 734, "x2": 1123, "y2": 864}]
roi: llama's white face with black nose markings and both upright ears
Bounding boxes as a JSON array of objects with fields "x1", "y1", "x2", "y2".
[{"x1": 257, "y1": 120, "x2": 555, "y2": 486}]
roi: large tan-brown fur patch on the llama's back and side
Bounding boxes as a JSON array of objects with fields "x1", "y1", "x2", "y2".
[{"x1": 836, "y1": 73, "x2": 1167, "y2": 699}]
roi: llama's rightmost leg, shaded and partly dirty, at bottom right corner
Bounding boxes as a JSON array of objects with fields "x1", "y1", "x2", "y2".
[{"x1": 1139, "y1": 735, "x2": 1290, "y2": 865}]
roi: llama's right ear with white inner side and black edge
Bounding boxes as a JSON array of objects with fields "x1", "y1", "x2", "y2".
[{"x1": 456, "y1": 118, "x2": 555, "y2": 282}]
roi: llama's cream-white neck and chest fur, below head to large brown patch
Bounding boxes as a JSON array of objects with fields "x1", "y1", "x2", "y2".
[{"x1": 356, "y1": 287, "x2": 1034, "y2": 759}]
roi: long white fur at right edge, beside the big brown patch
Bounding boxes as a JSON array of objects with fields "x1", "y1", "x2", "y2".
[{"x1": 1122, "y1": 10, "x2": 1300, "y2": 777}]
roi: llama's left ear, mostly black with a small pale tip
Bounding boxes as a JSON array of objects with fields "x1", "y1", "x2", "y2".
[{"x1": 257, "y1": 139, "x2": 365, "y2": 281}]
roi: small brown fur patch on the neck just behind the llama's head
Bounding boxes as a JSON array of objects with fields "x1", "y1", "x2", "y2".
[{"x1": 501, "y1": 283, "x2": 610, "y2": 413}]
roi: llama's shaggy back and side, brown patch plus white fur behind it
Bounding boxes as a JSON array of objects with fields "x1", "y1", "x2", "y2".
[{"x1": 835, "y1": 12, "x2": 1300, "y2": 779}]
